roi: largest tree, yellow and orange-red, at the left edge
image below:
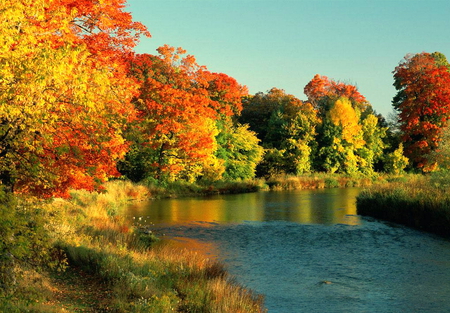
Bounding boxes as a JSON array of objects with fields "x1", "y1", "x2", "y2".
[{"x1": 0, "y1": 0, "x2": 150, "y2": 196}]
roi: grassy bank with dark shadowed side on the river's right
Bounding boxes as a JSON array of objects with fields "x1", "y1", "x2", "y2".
[{"x1": 357, "y1": 174, "x2": 450, "y2": 237}]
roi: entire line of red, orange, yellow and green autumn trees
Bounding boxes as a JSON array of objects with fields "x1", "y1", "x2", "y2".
[{"x1": 0, "y1": 0, "x2": 450, "y2": 197}]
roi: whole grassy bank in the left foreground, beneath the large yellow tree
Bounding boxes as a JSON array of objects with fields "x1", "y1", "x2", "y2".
[{"x1": 0, "y1": 181, "x2": 265, "y2": 312}]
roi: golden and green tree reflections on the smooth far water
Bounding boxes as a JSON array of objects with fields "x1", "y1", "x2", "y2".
[{"x1": 129, "y1": 188, "x2": 360, "y2": 226}]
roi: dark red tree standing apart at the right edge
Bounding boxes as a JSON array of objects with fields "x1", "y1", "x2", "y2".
[{"x1": 392, "y1": 52, "x2": 450, "y2": 169}]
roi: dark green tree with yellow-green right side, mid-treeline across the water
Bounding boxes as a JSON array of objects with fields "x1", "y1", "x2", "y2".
[{"x1": 240, "y1": 88, "x2": 318, "y2": 176}]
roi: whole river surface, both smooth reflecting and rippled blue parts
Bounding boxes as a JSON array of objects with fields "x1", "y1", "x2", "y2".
[{"x1": 126, "y1": 188, "x2": 450, "y2": 313}]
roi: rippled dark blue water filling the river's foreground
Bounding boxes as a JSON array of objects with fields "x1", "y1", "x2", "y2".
[{"x1": 154, "y1": 219, "x2": 450, "y2": 312}]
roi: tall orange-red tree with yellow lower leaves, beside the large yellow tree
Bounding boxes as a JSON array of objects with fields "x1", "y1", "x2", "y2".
[{"x1": 120, "y1": 50, "x2": 217, "y2": 180}]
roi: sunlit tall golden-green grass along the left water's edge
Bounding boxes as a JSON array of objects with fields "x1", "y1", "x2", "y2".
[{"x1": 0, "y1": 181, "x2": 266, "y2": 312}]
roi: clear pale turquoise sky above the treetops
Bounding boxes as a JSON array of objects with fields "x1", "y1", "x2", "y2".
[{"x1": 126, "y1": 0, "x2": 450, "y2": 117}]
